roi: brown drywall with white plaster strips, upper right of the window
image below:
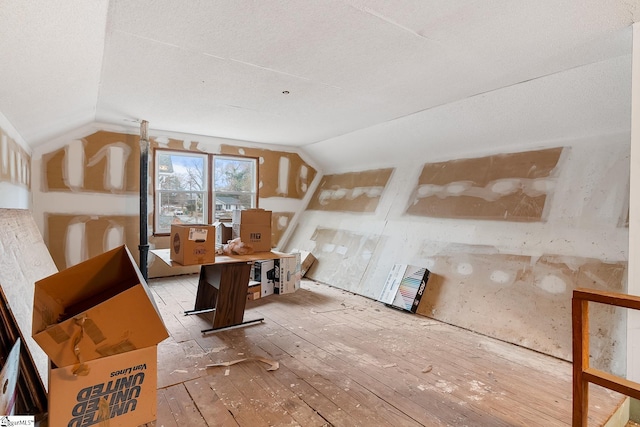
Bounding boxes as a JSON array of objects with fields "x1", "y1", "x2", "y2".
[{"x1": 220, "y1": 144, "x2": 317, "y2": 199}]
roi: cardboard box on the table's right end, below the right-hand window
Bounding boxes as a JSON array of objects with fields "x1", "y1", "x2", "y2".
[{"x1": 232, "y1": 209, "x2": 271, "y2": 252}]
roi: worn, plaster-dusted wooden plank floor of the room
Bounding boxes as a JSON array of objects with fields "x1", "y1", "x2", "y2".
[{"x1": 144, "y1": 275, "x2": 623, "y2": 427}]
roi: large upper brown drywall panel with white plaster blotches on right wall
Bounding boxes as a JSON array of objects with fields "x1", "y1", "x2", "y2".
[{"x1": 406, "y1": 147, "x2": 562, "y2": 221}]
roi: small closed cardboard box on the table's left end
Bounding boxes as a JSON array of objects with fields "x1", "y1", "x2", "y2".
[{"x1": 169, "y1": 224, "x2": 216, "y2": 265}]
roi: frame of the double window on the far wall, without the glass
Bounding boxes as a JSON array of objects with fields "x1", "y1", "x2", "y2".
[{"x1": 152, "y1": 147, "x2": 260, "y2": 236}]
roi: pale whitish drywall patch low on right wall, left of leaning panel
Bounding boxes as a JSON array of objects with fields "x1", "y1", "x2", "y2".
[{"x1": 306, "y1": 227, "x2": 381, "y2": 290}]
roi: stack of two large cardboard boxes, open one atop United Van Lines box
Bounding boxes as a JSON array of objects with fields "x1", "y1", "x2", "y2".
[{"x1": 32, "y1": 246, "x2": 169, "y2": 427}]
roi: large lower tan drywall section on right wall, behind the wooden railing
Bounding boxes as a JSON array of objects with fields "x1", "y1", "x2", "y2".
[{"x1": 418, "y1": 244, "x2": 627, "y2": 372}]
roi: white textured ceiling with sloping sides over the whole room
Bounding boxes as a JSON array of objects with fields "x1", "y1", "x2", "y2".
[{"x1": 0, "y1": 0, "x2": 640, "y2": 156}]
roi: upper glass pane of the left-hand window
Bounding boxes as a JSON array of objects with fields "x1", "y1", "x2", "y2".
[{"x1": 157, "y1": 151, "x2": 206, "y2": 191}]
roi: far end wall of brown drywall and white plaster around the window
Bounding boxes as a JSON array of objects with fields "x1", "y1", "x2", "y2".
[{"x1": 34, "y1": 127, "x2": 316, "y2": 277}]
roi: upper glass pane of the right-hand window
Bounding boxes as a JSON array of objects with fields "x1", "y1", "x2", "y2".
[{"x1": 213, "y1": 156, "x2": 255, "y2": 193}]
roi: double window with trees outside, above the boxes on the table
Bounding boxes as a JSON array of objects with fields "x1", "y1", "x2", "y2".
[{"x1": 154, "y1": 149, "x2": 258, "y2": 234}]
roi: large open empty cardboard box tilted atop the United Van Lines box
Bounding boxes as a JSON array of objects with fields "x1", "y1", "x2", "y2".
[{"x1": 32, "y1": 246, "x2": 169, "y2": 367}]
